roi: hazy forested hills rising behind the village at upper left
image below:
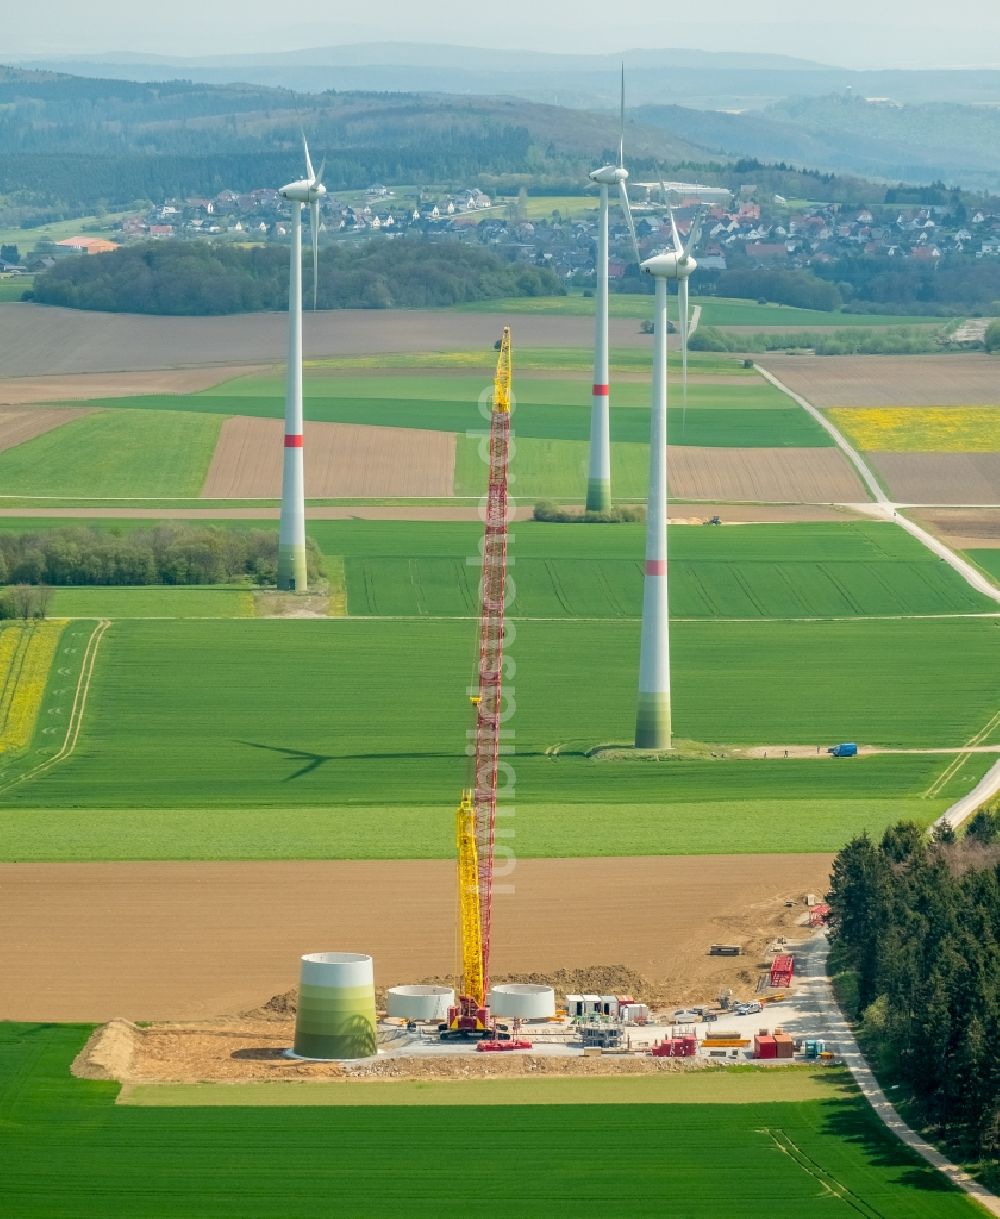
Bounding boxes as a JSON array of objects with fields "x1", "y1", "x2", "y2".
[{"x1": 0, "y1": 67, "x2": 704, "y2": 214}]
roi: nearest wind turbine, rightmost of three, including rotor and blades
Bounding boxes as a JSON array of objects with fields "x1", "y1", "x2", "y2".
[{"x1": 635, "y1": 212, "x2": 698, "y2": 750}]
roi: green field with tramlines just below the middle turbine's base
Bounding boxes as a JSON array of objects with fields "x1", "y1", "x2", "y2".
[{"x1": 310, "y1": 521, "x2": 991, "y2": 618}]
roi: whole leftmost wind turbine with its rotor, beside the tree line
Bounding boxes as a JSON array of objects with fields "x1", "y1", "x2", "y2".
[{"x1": 278, "y1": 135, "x2": 327, "y2": 592}]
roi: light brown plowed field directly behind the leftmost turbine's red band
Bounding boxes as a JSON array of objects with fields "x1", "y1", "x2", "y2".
[{"x1": 201, "y1": 416, "x2": 455, "y2": 500}]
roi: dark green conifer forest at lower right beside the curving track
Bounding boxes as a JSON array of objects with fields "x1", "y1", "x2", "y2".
[{"x1": 829, "y1": 811, "x2": 1000, "y2": 1168}]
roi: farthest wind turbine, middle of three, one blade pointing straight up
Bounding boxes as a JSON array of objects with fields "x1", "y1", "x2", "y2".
[{"x1": 587, "y1": 65, "x2": 639, "y2": 512}]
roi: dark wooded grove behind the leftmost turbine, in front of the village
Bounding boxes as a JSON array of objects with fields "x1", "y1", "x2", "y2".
[{"x1": 33, "y1": 241, "x2": 565, "y2": 315}]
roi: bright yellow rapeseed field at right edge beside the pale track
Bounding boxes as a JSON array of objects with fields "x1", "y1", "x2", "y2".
[{"x1": 828, "y1": 406, "x2": 1000, "y2": 453}]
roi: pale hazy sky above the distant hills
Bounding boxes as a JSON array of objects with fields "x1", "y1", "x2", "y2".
[{"x1": 0, "y1": 0, "x2": 1000, "y2": 68}]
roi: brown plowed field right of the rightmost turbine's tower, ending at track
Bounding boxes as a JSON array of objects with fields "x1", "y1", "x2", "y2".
[{"x1": 667, "y1": 445, "x2": 867, "y2": 503}]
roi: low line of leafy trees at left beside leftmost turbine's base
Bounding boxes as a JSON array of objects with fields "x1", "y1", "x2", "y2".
[{"x1": 0, "y1": 522, "x2": 323, "y2": 585}]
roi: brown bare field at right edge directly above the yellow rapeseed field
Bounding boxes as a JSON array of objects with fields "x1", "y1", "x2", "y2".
[{"x1": 761, "y1": 352, "x2": 1000, "y2": 406}]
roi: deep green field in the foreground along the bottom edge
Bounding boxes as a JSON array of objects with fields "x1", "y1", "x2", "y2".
[{"x1": 0, "y1": 1024, "x2": 977, "y2": 1219}]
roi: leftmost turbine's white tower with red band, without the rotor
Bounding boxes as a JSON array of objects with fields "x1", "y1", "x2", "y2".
[{"x1": 278, "y1": 202, "x2": 309, "y2": 592}]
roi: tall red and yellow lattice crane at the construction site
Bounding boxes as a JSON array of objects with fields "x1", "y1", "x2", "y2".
[{"x1": 441, "y1": 327, "x2": 511, "y2": 1040}]
